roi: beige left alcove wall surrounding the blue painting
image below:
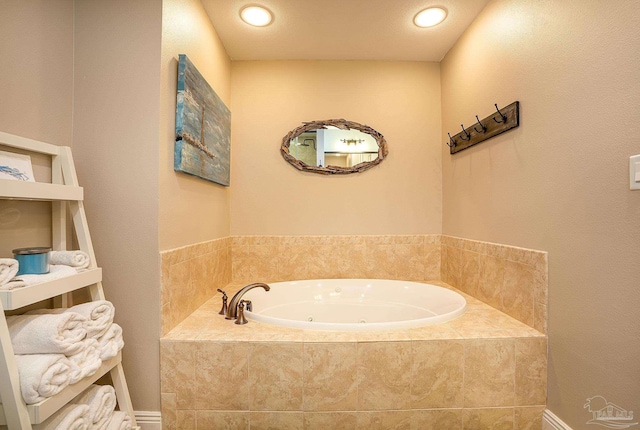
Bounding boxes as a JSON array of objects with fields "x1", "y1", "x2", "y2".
[{"x1": 159, "y1": 0, "x2": 231, "y2": 250}]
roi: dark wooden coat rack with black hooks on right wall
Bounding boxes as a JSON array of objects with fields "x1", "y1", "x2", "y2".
[{"x1": 445, "y1": 101, "x2": 520, "y2": 154}]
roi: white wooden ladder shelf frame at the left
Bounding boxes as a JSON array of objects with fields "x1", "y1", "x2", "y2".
[{"x1": 0, "y1": 132, "x2": 139, "y2": 430}]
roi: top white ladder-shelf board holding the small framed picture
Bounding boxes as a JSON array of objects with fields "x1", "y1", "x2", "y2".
[{"x1": 0, "y1": 179, "x2": 84, "y2": 201}]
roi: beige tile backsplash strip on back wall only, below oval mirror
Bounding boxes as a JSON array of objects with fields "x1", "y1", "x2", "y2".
[{"x1": 231, "y1": 234, "x2": 441, "y2": 283}]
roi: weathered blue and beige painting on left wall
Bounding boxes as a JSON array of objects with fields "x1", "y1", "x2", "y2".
[{"x1": 173, "y1": 54, "x2": 231, "y2": 186}]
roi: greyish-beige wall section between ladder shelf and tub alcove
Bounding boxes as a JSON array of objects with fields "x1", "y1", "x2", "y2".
[{"x1": 73, "y1": 0, "x2": 162, "y2": 411}]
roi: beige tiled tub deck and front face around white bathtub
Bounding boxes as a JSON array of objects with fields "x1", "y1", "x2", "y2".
[{"x1": 161, "y1": 282, "x2": 547, "y2": 430}]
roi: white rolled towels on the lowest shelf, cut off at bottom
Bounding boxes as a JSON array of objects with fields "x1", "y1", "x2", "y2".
[{"x1": 33, "y1": 385, "x2": 131, "y2": 430}]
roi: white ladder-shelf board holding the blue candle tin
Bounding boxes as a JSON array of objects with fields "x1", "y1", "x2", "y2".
[{"x1": 0, "y1": 268, "x2": 102, "y2": 311}]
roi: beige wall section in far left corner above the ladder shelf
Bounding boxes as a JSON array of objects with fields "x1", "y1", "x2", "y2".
[{"x1": 0, "y1": 0, "x2": 73, "y2": 146}]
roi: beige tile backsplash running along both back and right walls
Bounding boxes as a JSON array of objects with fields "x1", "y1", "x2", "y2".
[{"x1": 231, "y1": 235, "x2": 547, "y2": 333}]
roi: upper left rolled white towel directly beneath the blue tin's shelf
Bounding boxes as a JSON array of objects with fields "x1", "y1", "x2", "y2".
[{"x1": 7, "y1": 312, "x2": 87, "y2": 355}]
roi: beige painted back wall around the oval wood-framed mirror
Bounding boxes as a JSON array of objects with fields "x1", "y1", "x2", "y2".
[{"x1": 231, "y1": 61, "x2": 442, "y2": 235}]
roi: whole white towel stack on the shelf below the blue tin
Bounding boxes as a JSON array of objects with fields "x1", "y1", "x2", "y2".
[{"x1": 7, "y1": 300, "x2": 124, "y2": 404}]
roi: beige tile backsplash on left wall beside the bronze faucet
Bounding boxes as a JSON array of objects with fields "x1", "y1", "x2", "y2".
[{"x1": 160, "y1": 237, "x2": 231, "y2": 336}]
